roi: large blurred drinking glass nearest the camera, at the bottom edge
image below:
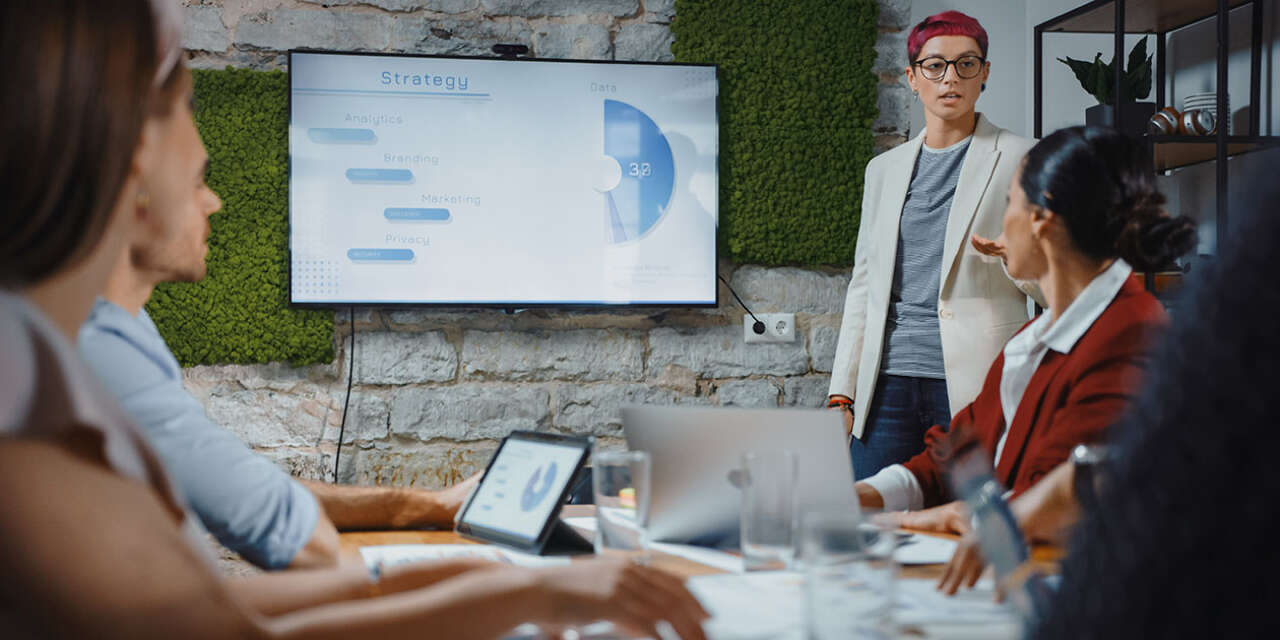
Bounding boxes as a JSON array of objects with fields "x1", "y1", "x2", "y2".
[{"x1": 801, "y1": 512, "x2": 897, "y2": 640}]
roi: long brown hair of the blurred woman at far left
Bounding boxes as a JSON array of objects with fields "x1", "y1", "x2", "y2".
[{"x1": 0, "y1": 0, "x2": 162, "y2": 288}]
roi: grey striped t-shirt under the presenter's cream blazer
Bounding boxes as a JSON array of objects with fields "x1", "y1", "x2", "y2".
[{"x1": 881, "y1": 136, "x2": 972, "y2": 379}]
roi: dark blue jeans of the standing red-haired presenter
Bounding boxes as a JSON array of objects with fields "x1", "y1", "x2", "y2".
[{"x1": 849, "y1": 374, "x2": 951, "y2": 480}]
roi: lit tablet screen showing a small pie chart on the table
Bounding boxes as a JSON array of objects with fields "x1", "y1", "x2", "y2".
[{"x1": 462, "y1": 439, "x2": 582, "y2": 540}]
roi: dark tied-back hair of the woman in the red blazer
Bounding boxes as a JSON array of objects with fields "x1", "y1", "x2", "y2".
[{"x1": 1020, "y1": 127, "x2": 1196, "y2": 271}]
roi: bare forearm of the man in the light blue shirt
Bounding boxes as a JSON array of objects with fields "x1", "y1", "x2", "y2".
[{"x1": 302, "y1": 480, "x2": 453, "y2": 531}]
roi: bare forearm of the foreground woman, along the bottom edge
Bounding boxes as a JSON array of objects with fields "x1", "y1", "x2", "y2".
[{"x1": 266, "y1": 567, "x2": 549, "y2": 640}]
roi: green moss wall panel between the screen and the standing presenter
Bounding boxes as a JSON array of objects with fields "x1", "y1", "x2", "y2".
[{"x1": 671, "y1": 0, "x2": 879, "y2": 266}]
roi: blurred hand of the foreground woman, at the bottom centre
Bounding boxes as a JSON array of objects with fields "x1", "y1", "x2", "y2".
[{"x1": 535, "y1": 558, "x2": 710, "y2": 640}]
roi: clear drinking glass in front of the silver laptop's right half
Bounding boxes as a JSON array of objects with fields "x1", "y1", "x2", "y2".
[{"x1": 741, "y1": 451, "x2": 800, "y2": 571}]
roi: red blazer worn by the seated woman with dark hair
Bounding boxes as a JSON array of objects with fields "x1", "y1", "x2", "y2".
[{"x1": 905, "y1": 276, "x2": 1169, "y2": 507}]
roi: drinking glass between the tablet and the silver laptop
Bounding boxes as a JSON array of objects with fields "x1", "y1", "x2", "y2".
[{"x1": 591, "y1": 451, "x2": 652, "y2": 557}]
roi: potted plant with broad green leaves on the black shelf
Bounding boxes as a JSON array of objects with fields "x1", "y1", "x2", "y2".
[{"x1": 1059, "y1": 38, "x2": 1156, "y2": 136}]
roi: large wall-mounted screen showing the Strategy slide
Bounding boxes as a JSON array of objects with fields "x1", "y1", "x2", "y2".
[{"x1": 289, "y1": 52, "x2": 718, "y2": 306}]
